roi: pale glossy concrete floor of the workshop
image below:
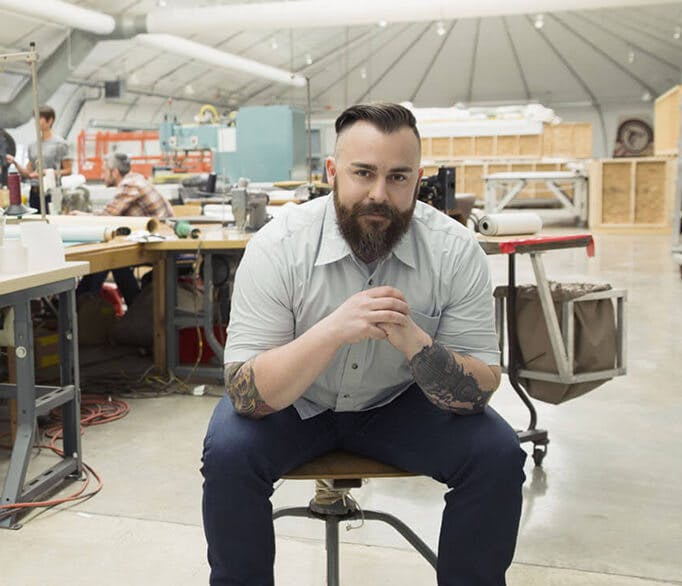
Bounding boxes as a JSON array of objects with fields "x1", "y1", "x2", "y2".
[{"x1": 0, "y1": 230, "x2": 682, "y2": 586}]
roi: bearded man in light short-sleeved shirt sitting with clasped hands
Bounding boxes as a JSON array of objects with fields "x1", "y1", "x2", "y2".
[{"x1": 202, "y1": 104, "x2": 525, "y2": 586}]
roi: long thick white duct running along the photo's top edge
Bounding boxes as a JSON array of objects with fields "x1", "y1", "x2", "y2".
[{"x1": 146, "y1": 0, "x2": 676, "y2": 35}]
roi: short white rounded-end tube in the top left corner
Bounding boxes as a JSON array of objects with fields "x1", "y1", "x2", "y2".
[{"x1": 0, "y1": 0, "x2": 116, "y2": 35}]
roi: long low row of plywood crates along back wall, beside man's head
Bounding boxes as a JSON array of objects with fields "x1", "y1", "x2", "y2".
[{"x1": 422, "y1": 122, "x2": 592, "y2": 161}]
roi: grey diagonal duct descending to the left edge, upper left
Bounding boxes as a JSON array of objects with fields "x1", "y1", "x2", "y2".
[{"x1": 0, "y1": 31, "x2": 98, "y2": 128}]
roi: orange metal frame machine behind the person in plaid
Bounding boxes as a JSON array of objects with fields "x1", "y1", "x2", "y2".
[{"x1": 78, "y1": 130, "x2": 213, "y2": 181}]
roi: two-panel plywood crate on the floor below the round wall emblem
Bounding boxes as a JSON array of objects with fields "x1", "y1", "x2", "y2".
[{"x1": 589, "y1": 157, "x2": 676, "y2": 232}]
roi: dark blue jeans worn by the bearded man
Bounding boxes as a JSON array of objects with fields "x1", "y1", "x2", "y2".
[{"x1": 202, "y1": 385, "x2": 525, "y2": 586}]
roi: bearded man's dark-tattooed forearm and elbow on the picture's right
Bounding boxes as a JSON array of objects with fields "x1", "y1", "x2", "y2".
[{"x1": 409, "y1": 340, "x2": 500, "y2": 415}]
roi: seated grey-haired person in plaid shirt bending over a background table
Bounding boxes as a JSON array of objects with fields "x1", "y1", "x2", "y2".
[{"x1": 71, "y1": 153, "x2": 173, "y2": 307}]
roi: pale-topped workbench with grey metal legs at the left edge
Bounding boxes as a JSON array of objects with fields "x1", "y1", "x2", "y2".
[{"x1": 0, "y1": 262, "x2": 89, "y2": 528}]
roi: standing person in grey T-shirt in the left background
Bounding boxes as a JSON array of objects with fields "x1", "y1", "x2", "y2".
[{"x1": 6, "y1": 106, "x2": 73, "y2": 209}]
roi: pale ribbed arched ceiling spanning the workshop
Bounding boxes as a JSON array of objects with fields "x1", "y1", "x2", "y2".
[{"x1": 0, "y1": 0, "x2": 682, "y2": 120}]
